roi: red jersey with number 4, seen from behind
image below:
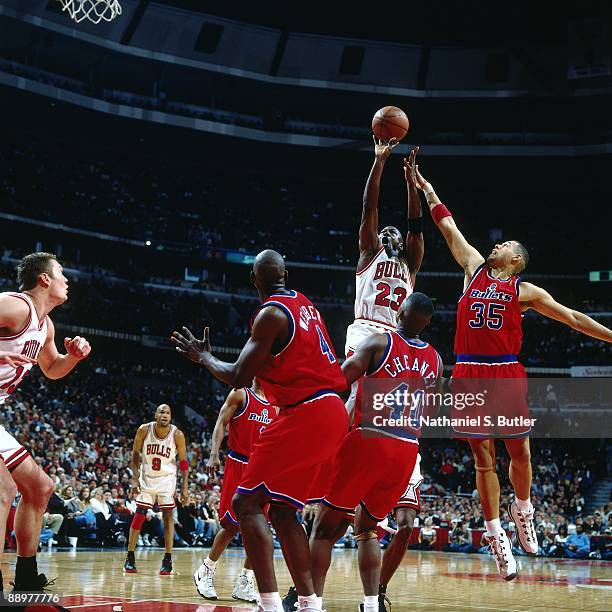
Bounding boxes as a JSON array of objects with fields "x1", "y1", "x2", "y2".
[{"x1": 256, "y1": 291, "x2": 346, "y2": 407}]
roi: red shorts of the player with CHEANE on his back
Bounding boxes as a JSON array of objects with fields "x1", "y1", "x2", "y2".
[{"x1": 323, "y1": 429, "x2": 419, "y2": 521}]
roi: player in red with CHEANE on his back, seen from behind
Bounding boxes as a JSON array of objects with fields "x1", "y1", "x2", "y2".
[{"x1": 311, "y1": 293, "x2": 442, "y2": 612}]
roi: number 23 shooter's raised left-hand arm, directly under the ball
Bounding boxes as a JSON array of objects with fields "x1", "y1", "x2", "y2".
[{"x1": 357, "y1": 136, "x2": 397, "y2": 270}]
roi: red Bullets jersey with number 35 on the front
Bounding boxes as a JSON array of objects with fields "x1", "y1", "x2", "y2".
[{"x1": 455, "y1": 264, "x2": 523, "y2": 363}]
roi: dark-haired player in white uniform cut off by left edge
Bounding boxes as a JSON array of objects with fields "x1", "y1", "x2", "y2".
[{"x1": 0, "y1": 252, "x2": 91, "y2": 592}]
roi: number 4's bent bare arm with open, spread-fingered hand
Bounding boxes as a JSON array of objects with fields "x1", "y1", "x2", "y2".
[{"x1": 171, "y1": 306, "x2": 289, "y2": 388}]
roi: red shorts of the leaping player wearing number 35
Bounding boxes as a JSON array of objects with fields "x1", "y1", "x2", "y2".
[{"x1": 451, "y1": 362, "x2": 532, "y2": 438}]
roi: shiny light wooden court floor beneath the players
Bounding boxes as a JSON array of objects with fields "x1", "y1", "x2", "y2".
[{"x1": 2, "y1": 548, "x2": 612, "y2": 612}]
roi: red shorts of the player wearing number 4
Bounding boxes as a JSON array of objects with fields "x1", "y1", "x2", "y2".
[{"x1": 237, "y1": 393, "x2": 348, "y2": 508}]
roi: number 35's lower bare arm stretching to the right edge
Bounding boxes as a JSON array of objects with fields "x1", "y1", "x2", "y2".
[{"x1": 519, "y1": 283, "x2": 612, "y2": 342}]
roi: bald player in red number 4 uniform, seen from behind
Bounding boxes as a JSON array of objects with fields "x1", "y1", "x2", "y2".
[{"x1": 172, "y1": 250, "x2": 349, "y2": 612}]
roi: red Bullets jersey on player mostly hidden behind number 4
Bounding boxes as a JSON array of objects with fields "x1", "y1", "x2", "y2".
[{"x1": 227, "y1": 388, "x2": 276, "y2": 461}]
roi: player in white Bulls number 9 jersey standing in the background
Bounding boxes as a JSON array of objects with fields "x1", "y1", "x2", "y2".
[{"x1": 123, "y1": 404, "x2": 189, "y2": 576}]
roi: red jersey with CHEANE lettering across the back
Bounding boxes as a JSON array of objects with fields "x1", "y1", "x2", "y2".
[{"x1": 354, "y1": 332, "x2": 442, "y2": 441}]
